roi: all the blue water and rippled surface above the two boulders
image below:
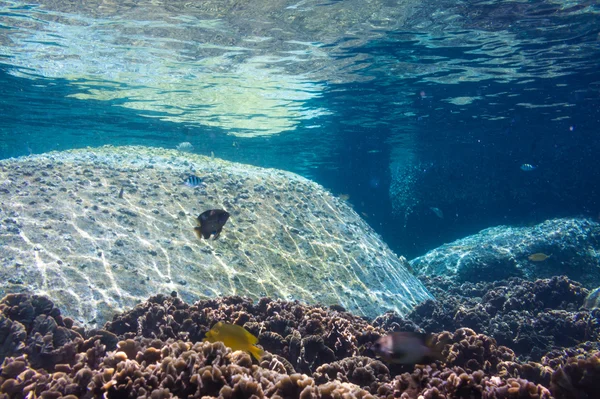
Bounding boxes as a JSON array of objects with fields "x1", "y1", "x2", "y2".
[{"x1": 0, "y1": 1, "x2": 600, "y2": 258}]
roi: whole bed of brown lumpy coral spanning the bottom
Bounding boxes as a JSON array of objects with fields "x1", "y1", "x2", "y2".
[{"x1": 0, "y1": 278, "x2": 600, "y2": 399}]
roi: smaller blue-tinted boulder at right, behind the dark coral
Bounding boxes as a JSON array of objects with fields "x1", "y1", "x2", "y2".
[{"x1": 410, "y1": 218, "x2": 600, "y2": 288}]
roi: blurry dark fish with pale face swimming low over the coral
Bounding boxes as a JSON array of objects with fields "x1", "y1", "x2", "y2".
[{"x1": 371, "y1": 332, "x2": 446, "y2": 364}]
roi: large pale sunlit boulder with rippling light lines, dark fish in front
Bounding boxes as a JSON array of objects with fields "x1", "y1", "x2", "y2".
[{"x1": 0, "y1": 146, "x2": 430, "y2": 323}]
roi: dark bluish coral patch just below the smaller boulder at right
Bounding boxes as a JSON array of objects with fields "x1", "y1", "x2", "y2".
[{"x1": 408, "y1": 277, "x2": 600, "y2": 361}]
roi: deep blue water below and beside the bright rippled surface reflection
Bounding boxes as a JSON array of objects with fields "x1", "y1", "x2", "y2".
[{"x1": 0, "y1": 2, "x2": 600, "y2": 258}]
